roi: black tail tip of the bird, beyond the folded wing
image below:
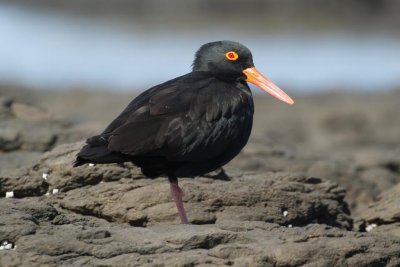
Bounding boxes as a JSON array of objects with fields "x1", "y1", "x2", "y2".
[{"x1": 73, "y1": 135, "x2": 126, "y2": 167}]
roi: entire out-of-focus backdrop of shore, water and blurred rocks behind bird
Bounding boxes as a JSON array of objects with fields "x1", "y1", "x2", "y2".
[{"x1": 0, "y1": 0, "x2": 400, "y2": 218}]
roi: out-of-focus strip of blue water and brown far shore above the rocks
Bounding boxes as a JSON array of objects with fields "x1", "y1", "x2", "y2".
[{"x1": 0, "y1": 0, "x2": 400, "y2": 92}]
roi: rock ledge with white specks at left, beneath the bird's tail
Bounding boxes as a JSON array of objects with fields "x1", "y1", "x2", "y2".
[{"x1": 0, "y1": 142, "x2": 139, "y2": 197}]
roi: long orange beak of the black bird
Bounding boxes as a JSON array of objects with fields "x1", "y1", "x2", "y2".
[{"x1": 243, "y1": 67, "x2": 294, "y2": 105}]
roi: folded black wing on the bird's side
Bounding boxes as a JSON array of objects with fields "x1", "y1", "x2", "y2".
[{"x1": 101, "y1": 72, "x2": 250, "y2": 161}]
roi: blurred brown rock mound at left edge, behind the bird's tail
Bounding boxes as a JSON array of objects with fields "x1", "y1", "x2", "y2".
[{"x1": 0, "y1": 95, "x2": 96, "y2": 174}]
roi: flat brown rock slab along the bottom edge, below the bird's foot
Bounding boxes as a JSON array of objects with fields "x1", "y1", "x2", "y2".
[{"x1": 0, "y1": 207, "x2": 400, "y2": 266}]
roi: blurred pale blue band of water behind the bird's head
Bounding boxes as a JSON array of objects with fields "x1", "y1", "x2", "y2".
[{"x1": 0, "y1": 4, "x2": 400, "y2": 92}]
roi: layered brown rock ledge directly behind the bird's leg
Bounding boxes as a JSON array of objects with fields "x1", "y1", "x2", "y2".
[{"x1": 59, "y1": 174, "x2": 352, "y2": 229}]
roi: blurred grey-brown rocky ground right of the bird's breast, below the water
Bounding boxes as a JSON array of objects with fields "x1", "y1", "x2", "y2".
[{"x1": 231, "y1": 90, "x2": 400, "y2": 216}]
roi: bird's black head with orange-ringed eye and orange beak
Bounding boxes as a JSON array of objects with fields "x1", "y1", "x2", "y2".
[{"x1": 193, "y1": 41, "x2": 294, "y2": 105}]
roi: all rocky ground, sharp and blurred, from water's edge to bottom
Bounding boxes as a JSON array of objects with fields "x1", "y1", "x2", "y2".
[{"x1": 0, "y1": 88, "x2": 400, "y2": 266}]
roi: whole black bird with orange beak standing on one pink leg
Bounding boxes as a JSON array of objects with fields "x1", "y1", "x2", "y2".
[{"x1": 74, "y1": 41, "x2": 294, "y2": 223}]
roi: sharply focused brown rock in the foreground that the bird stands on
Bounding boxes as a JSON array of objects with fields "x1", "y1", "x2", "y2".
[{"x1": 0, "y1": 142, "x2": 400, "y2": 266}]
